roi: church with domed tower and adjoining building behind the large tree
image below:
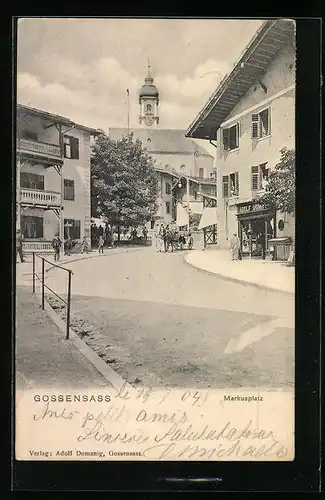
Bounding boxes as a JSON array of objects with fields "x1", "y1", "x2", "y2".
[{"x1": 108, "y1": 66, "x2": 216, "y2": 230}]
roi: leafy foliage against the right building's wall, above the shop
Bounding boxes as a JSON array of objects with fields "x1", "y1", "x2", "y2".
[{"x1": 254, "y1": 148, "x2": 296, "y2": 215}]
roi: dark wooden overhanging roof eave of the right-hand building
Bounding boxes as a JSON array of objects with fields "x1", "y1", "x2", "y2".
[{"x1": 185, "y1": 19, "x2": 295, "y2": 139}]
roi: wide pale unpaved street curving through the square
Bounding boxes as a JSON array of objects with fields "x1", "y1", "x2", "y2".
[{"x1": 41, "y1": 248, "x2": 294, "y2": 388}]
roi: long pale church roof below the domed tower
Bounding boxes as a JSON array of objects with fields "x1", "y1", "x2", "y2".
[{"x1": 108, "y1": 128, "x2": 213, "y2": 158}]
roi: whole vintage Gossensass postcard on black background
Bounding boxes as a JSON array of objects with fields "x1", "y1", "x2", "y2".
[{"x1": 15, "y1": 17, "x2": 296, "y2": 462}]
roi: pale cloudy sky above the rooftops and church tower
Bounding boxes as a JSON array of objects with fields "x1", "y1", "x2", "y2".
[{"x1": 17, "y1": 18, "x2": 263, "y2": 147}]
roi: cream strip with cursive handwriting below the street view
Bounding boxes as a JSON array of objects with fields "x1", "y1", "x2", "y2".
[{"x1": 17, "y1": 385, "x2": 293, "y2": 460}]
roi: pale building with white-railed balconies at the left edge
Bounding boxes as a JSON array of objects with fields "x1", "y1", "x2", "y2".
[{"x1": 16, "y1": 105, "x2": 97, "y2": 253}]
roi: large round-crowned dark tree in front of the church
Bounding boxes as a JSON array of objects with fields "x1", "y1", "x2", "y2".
[{"x1": 91, "y1": 132, "x2": 158, "y2": 233}]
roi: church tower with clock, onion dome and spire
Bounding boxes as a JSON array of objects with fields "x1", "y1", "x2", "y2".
[{"x1": 139, "y1": 62, "x2": 159, "y2": 128}]
